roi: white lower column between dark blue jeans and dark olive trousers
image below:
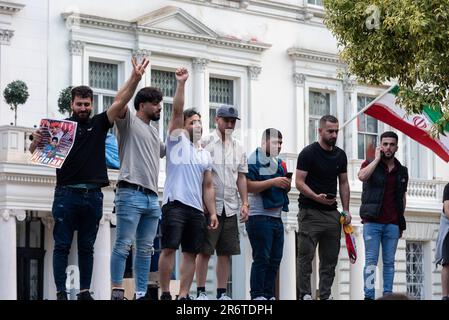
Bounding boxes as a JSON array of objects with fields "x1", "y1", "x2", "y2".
[{"x1": 279, "y1": 211, "x2": 298, "y2": 300}]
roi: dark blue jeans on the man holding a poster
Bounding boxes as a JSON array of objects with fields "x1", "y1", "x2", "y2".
[{"x1": 52, "y1": 187, "x2": 103, "y2": 292}]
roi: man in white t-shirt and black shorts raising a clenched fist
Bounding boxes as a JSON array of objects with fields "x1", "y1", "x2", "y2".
[{"x1": 159, "y1": 68, "x2": 218, "y2": 300}]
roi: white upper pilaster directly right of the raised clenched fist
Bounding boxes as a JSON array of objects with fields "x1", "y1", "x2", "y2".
[{"x1": 192, "y1": 58, "x2": 209, "y2": 134}]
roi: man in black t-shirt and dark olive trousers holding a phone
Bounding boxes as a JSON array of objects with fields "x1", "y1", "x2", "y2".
[{"x1": 296, "y1": 115, "x2": 351, "y2": 300}]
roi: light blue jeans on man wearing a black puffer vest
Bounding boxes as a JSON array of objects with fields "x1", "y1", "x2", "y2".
[{"x1": 363, "y1": 222, "x2": 399, "y2": 299}]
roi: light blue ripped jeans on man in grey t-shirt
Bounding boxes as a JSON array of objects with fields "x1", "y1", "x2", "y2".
[{"x1": 111, "y1": 188, "x2": 161, "y2": 292}]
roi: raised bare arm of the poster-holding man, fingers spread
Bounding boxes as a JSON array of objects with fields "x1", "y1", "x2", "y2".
[{"x1": 106, "y1": 58, "x2": 150, "y2": 124}]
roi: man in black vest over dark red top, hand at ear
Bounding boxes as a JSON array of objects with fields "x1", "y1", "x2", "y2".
[{"x1": 358, "y1": 131, "x2": 408, "y2": 300}]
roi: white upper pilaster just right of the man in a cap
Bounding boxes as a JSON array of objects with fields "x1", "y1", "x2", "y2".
[{"x1": 246, "y1": 66, "x2": 263, "y2": 152}]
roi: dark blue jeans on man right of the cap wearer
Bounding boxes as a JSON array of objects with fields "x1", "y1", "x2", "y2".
[{"x1": 246, "y1": 216, "x2": 284, "y2": 299}]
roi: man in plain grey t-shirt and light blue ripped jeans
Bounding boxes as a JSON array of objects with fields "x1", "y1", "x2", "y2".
[{"x1": 111, "y1": 82, "x2": 165, "y2": 300}]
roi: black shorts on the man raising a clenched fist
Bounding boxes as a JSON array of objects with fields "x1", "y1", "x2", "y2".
[{"x1": 161, "y1": 201, "x2": 207, "y2": 253}]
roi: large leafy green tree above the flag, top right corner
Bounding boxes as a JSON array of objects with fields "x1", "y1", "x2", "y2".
[{"x1": 324, "y1": 0, "x2": 449, "y2": 132}]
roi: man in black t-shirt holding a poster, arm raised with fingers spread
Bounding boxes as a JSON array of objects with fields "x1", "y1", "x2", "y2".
[{"x1": 30, "y1": 59, "x2": 148, "y2": 300}]
